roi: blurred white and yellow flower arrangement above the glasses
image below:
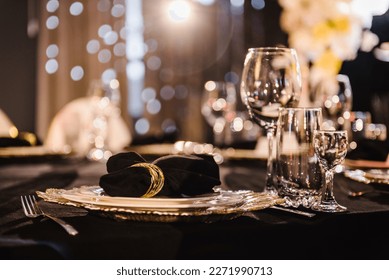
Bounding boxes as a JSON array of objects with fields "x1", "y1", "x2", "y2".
[{"x1": 279, "y1": 0, "x2": 382, "y2": 91}]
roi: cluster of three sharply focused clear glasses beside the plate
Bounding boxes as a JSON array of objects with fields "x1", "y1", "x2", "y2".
[{"x1": 241, "y1": 47, "x2": 348, "y2": 212}]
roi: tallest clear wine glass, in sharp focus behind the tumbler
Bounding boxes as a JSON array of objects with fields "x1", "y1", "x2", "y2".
[{"x1": 241, "y1": 47, "x2": 301, "y2": 194}]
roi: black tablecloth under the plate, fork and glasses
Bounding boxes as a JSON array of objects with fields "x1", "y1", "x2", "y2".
[{"x1": 0, "y1": 154, "x2": 389, "y2": 260}]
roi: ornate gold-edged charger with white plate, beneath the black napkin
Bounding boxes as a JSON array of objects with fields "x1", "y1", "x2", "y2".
[{"x1": 37, "y1": 186, "x2": 284, "y2": 222}]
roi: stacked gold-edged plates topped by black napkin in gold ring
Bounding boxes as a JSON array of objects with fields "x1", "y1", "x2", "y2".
[{"x1": 37, "y1": 152, "x2": 283, "y2": 222}]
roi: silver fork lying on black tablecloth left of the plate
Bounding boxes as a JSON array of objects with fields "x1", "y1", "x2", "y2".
[{"x1": 20, "y1": 195, "x2": 78, "y2": 235}]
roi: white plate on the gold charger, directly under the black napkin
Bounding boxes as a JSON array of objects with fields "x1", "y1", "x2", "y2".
[{"x1": 61, "y1": 186, "x2": 242, "y2": 210}]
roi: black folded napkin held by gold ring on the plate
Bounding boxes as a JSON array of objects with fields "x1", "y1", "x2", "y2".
[{"x1": 100, "y1": 152, "x2": 221, "y2": 197}]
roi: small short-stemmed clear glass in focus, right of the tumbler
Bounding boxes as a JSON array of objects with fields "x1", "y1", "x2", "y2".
[{"x1": 312, "y1": 130, "x2": 348, "y2": 212}]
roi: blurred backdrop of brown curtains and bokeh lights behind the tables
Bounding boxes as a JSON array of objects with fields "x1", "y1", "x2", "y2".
[{"x1": 0, "y1": 0, "x2": 389, "y2": 155}]
